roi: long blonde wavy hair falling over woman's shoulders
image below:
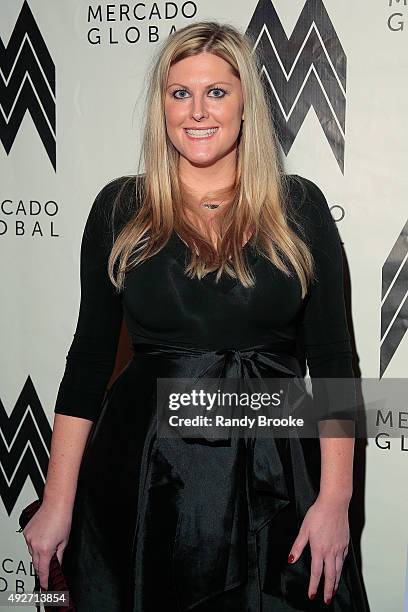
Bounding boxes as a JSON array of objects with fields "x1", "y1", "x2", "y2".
[{"x1": 108, "y1": 21, "x2": 314, "y2": 298}]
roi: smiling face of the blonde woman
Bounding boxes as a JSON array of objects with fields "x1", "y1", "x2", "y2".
[{"x1": 165, "y1": 53, "x2": 243, "y2": 166}]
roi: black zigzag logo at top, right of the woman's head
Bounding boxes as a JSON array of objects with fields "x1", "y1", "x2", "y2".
[{"x1": 246, "y1": 0, "x2": 347, "y2": 174}]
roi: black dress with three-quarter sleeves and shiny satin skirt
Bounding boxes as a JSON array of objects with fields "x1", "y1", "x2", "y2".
[{"x1": 54, "y1": 175, "x2": 366, "y2": 612}]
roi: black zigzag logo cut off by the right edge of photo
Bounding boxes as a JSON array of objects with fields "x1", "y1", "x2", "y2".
[{"x1": 380, "y1": 221, "x2": 408, "y2": 378}]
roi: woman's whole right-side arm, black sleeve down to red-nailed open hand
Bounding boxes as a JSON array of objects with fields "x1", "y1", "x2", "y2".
[{"x1": 289, "y1": 177, "x2": 356, "y2": 603}]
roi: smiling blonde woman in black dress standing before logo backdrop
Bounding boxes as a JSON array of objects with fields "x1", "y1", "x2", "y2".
[{"x1": 24, "y1": 22, "x2": 365, "y2": 612}]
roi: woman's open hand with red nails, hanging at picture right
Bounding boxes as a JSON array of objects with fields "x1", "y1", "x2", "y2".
[{"x1": 289, "y1": 495, "x2": 350, "y2": 604}]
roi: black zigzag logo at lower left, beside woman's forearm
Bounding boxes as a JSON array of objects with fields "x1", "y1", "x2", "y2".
[{"x1": 0, "y1": 376, "x2": 52, "y2": 516}]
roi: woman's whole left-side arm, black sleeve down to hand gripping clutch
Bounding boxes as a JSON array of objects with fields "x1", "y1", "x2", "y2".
[{"x1": 23, "y1": 179, "x2": 135, "y2": 588}]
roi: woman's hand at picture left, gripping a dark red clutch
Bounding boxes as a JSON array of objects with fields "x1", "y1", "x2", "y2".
[{"x1": 22, "y1": 501, "x2": 72, "y2": 589}]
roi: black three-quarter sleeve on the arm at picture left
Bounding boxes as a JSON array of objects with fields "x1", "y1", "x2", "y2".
[{"x1": 54, "y1": 179, "x2": 128, "y2": 421}]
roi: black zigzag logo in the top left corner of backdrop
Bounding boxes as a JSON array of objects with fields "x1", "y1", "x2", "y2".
[{"x1": 0, "y1": 0, "x2": 56, "y2": 170}]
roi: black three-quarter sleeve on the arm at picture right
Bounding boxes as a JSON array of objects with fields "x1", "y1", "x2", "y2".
[{"x1": 299, "y1": 177, "x2": 356, "y2": 421}]
